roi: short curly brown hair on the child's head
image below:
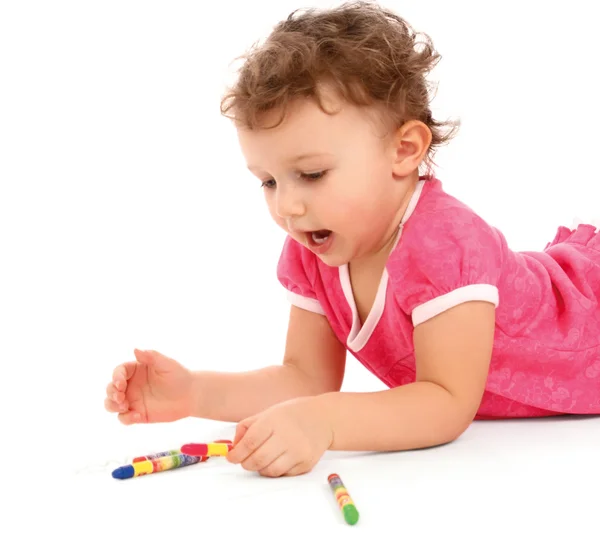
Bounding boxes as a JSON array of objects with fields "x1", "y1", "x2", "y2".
[{"x1": 221, "y1": 1, "x2": 459, "y2": 174}]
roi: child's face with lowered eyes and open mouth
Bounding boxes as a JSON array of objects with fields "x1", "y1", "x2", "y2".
[{"x1": 238, "y1": 89, "x2": 416, "y2": 266}]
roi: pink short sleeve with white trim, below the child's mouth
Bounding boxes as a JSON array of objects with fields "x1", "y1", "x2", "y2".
[{"x1": 277, "y1": 236, "x2": 325, "y2": 314}]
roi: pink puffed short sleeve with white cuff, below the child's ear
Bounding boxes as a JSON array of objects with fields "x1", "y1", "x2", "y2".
[{"x1": 386, "y1": 207, "x2": 506, "y2": 326}]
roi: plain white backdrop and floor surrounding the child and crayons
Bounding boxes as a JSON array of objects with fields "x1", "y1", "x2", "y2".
[{"x1": 0, "y1": 0, "x2": 600, "y2": 554}]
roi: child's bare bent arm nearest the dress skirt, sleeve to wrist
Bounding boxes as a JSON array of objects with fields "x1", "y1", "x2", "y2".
[{"x1": 320, "y1": 302, "x2": 495, "y2": 451}]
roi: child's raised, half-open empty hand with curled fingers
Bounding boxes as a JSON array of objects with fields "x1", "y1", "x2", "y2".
[{"x1": 104, "y1": 349, "x2": 192, "y2": 424}]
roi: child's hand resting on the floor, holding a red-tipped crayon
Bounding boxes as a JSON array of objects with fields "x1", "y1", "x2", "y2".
[{"x1": 227, "y1": 397, "x2": 333, "y2": 478}]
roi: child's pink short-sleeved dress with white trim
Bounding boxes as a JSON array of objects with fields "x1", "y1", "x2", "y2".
[{"x1": 277, "y1": 178, "x2": 600, "y2": 419}]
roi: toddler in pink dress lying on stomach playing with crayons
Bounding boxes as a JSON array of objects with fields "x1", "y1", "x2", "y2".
[{"x1": 105, "y1": 2, "x2": 600, "y2": 477}]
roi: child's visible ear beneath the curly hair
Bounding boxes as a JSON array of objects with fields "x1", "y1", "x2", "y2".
[{"x1": 391, "y1": 120, "x2": 432, "y2": 177}]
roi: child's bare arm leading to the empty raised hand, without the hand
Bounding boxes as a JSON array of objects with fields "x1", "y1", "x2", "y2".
[{"x1": 191, "y1": 306, "x2": 346, "y2": 422}]
